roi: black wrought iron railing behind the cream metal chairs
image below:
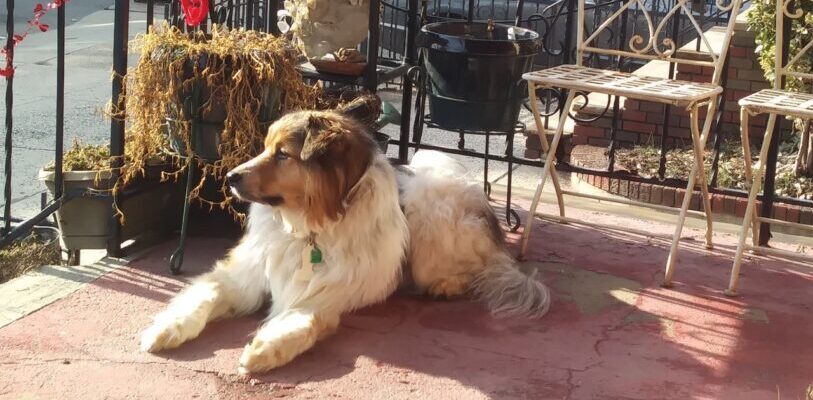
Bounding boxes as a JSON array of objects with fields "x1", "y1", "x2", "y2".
[{"x1": 407, "y1": 0, "x2": 813, "y2": 244}]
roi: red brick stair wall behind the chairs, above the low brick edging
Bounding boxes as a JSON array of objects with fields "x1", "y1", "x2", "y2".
[{"x1": 573, "y1": 18, "x2": 769, "y2": 146}]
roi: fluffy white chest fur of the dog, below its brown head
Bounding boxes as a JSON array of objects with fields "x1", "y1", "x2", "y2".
[{"x1": 244, "y1": 190, "x2": 408, "y2": 315}]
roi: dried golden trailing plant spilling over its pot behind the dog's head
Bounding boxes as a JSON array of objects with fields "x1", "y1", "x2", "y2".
[{"x1": 113, "y1": 24, "x2": 320, "y2": 217}]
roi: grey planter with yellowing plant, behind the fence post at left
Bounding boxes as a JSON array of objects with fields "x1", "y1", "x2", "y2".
[{"x1": 39, "y1": 140, "x2": 180, "y2": 253}]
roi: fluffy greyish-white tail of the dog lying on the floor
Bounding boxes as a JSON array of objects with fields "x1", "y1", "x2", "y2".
[{"x1": 472, "y1": 254, "x2": 551, "y2": 318}]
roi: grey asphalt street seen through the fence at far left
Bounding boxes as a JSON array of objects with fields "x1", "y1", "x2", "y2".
[{"x1": 0, "y1": 0, "x2": 146, "y2": 218}]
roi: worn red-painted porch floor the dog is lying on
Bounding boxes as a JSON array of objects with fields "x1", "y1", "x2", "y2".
[{"x1": 0, "y1": 202, "x2": 813, "y2": 399}]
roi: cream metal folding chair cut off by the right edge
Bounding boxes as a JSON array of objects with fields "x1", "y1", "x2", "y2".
[{"x1": 726, "y1": 0, "x2": 813, "y2": 296}]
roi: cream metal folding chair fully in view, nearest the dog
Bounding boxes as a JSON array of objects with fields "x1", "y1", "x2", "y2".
[{"x1": 520, "y1": 0, "x2": 742, "y2": 286}]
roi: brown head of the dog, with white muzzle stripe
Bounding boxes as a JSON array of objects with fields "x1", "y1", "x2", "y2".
[{"x1": 226, "y1": 111, "x2": 377, "y2": 225}]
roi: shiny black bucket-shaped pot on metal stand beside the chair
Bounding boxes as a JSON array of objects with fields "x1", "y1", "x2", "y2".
[{"x1": 418, "y1": 21, "x2": 541, "y2": 132}]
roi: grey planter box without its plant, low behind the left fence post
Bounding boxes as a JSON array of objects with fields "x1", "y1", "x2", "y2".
[{"x1": 38, "y1": 166, "x2": 183, "y2": 251}]
